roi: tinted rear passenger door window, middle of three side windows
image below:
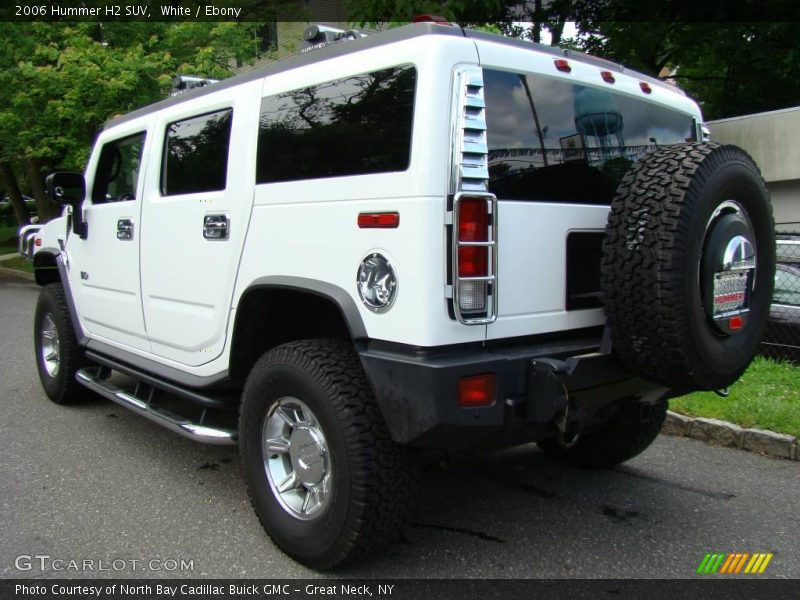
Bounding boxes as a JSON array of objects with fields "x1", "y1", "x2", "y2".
[{"x1": 161, "y1": 109, "x2": 233, "y2": 196}]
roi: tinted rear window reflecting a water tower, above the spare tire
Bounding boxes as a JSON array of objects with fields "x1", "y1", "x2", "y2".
[{"x1": 483, "y1": 69, "x2": 694, "y2": 204}]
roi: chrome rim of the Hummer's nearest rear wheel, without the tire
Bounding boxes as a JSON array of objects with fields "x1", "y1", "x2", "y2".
[{"x1": 261, "y1": 397, "x2": 332, "y2": 520}]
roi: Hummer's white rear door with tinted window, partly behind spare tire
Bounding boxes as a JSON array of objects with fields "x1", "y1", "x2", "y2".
[{"x1": 479, "y1": 42, "x2": 699, "y2": 339}]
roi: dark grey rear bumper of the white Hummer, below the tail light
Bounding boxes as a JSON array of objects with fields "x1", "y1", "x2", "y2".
[{"x1": 359, "y1": 337, "x2": 669, "y2": 448}]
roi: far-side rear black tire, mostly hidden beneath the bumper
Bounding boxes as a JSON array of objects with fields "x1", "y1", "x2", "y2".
[{"x1": 538, "y1": 402, "x2": 667, "y2": 469}]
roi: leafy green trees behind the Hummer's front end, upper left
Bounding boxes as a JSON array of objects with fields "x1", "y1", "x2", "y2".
[{"x1": 0, "y1": 22, "x2": 257, "y2": 221}]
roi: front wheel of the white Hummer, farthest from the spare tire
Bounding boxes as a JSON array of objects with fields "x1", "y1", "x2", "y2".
[{"x1": 33, "y1": 283, "x2": 89, "y2": 404}]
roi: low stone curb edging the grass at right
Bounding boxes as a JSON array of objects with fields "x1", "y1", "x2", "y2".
[{"x1": 661, "y1": 410, "x2": 800, "y2": 461}]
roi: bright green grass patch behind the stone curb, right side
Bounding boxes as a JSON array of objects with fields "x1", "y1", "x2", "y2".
[{"x1": 670, "y1": 356, "x2": 800, "y2": 437}]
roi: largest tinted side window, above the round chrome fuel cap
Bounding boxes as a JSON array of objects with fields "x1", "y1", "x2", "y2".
[{"x1": 256, "y1": 66, "x2": 416, "y2": 183}]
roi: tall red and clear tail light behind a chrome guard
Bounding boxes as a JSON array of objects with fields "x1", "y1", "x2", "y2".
[{"x1": 453, "y1": 194, "x2": 497, "y2": 325}]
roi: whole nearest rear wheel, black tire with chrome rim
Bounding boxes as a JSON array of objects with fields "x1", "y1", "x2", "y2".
[{"x1": 239, "y1": 340, "x2": 411, "y2": 569}]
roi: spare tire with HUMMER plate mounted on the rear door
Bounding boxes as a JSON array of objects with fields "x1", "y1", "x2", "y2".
[{"x1": 601, "y1": 142, "x2": 775, "y2": 392}]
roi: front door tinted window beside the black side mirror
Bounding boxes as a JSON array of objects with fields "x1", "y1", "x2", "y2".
[{"x1": 92, "y1": 133, "x2": 145, "y2": 204}]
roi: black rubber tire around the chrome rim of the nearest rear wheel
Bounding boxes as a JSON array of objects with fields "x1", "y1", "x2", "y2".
[{"x1": 239, "y1": 340, "x2": 411, "y2": 570}]
